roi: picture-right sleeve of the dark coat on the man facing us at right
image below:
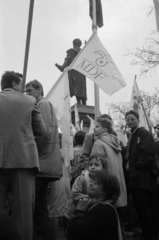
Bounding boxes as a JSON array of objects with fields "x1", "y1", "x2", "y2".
[{"x1": 135, "y1": 129, "x2": 155, "y2": 170}]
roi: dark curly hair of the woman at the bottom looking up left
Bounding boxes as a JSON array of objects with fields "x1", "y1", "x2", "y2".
[{"x1": 95, "y1": 170, "x2": 121, "y2": 203}]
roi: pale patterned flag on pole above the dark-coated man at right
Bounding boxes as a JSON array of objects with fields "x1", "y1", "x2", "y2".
[{"x1": 129, "y1": 79, "x2": 149, "y2": 130}]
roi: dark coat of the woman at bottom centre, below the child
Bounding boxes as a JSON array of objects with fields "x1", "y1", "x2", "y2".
[{"x1": 68, "y1": 203, "x2": 118, "y2": 240}]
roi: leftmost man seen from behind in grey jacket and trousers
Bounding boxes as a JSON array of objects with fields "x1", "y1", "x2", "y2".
[{"x1": 0, "y1": 71, "x2": 45, "y2": 240}]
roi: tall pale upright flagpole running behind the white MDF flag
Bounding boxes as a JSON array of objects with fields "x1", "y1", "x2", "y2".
[{"x1": 92, "y1": 0, "x2": 100, "y2": 119}]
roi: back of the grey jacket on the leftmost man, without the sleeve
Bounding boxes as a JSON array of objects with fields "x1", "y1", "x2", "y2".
[{"x1": 0, "y1": 89, "x2": 39, "y2": 168}]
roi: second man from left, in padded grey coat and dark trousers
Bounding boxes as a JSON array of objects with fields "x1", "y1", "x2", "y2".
[{"x1": 26, "y1": 80, "x2": 62, "y2": 239}]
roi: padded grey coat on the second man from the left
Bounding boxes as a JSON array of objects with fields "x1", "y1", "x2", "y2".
[{"x1": 36, "y1": 98, "x2": 62, "y2": 180}]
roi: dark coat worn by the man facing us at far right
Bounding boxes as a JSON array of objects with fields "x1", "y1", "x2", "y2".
[{"x1": 128, "y1": 127, "x2": 157, "y2": 193}]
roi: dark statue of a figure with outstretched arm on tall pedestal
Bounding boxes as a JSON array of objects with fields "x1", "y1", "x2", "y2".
[{"x1": 55, "y1": 38, "x2": 87, "y2": 105}]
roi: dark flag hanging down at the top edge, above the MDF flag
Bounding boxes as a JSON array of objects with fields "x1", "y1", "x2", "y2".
[{"x1": 89, "y1": 0, "x2": 103, "y2": 27}]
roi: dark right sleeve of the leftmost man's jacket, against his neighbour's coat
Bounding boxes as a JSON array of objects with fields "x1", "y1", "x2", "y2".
[{"x1": 32, "y1": 104, "x2": 46, "y2": 137}]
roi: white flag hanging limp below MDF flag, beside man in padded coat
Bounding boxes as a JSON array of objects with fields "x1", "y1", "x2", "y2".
[{"x1": 46, "y1": 70, "x2": 73, "y2": 167}]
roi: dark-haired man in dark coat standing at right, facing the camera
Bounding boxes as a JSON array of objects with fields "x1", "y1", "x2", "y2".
[{"x1": 125, "y1": 110, "x2": 158, "y2": 240}]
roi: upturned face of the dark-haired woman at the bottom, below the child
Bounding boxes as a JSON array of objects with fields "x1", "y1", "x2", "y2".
[{"x1": 88, "y1": 180, "x2": 105, "y2": 200}]
